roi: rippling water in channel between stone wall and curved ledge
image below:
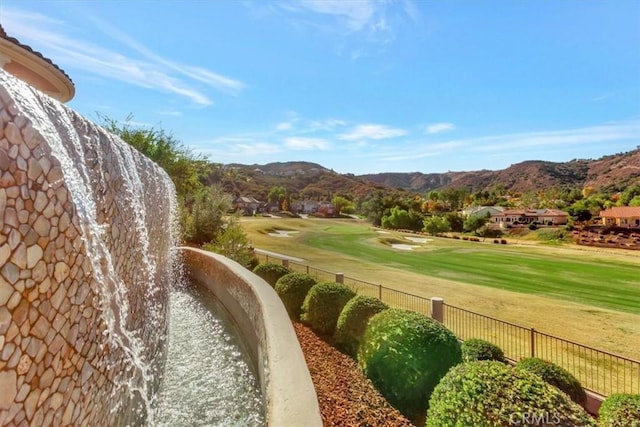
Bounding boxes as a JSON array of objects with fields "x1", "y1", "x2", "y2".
[{"x1": 153, "y1": 285, "x2": 266, "y2": 427}]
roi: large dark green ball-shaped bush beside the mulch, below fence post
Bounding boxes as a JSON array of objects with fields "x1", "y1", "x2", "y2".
[{"x1": 358, "y1": 309, "x2": 462, "y2": 423}]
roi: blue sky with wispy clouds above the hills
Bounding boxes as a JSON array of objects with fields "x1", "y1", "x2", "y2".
[{"x1": 0, "y1": 0, "x2": 640, "y2": 174}]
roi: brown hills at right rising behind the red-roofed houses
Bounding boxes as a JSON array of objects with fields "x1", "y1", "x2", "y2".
[{"x1": 358, "y1": 149, "x2": 640, "y2": 193}]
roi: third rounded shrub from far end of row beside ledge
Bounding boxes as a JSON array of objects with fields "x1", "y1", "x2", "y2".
[{"x1": 300, "y1": 282, "x2": 356, "y2": 335}]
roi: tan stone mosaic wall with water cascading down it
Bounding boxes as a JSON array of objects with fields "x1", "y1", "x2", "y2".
[{"x1": 0, "y1": 70, "x2": 174, "y2": 426}]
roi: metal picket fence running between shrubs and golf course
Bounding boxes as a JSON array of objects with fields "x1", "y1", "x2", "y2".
[{"x1": 257, "y1": 254, "x2": 640, "y2": 396}]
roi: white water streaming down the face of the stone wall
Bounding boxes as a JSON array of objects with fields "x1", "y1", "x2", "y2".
[{"x1": 0, "y1": 73, "x2": 176, "y2": 425}]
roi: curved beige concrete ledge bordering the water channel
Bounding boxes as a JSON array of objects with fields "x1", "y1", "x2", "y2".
[{"x1": 180, "y1": 247, "x2": 322, "y2": 427}]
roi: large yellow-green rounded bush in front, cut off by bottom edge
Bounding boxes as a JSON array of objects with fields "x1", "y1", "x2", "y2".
[{"x1": 426, "y1": 360, "x2": 596, "y2": 427}]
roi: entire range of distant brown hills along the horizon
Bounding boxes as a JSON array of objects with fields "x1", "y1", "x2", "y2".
[{"x1": 219, "y1": 149, "x2": 640, "y2": 200}]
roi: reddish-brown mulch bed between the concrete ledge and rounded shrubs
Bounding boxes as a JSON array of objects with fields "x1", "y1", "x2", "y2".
[{"x1": 293, "y1": 323, "x2": 413, "y2": 427}]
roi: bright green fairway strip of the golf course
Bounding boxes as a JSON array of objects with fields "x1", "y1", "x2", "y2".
[{"x1": 249, "y1": 221, "x2": 640, "y2": 314}]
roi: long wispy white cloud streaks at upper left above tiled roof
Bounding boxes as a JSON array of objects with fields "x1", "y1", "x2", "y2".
[{"x1": 3, "y1": 8, "x2": 245, "y2": 106}]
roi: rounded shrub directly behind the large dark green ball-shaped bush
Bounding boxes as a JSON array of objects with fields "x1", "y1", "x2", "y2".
[{"x1": 334, "y1": 295, "x2": 389, "y2": 357}]
